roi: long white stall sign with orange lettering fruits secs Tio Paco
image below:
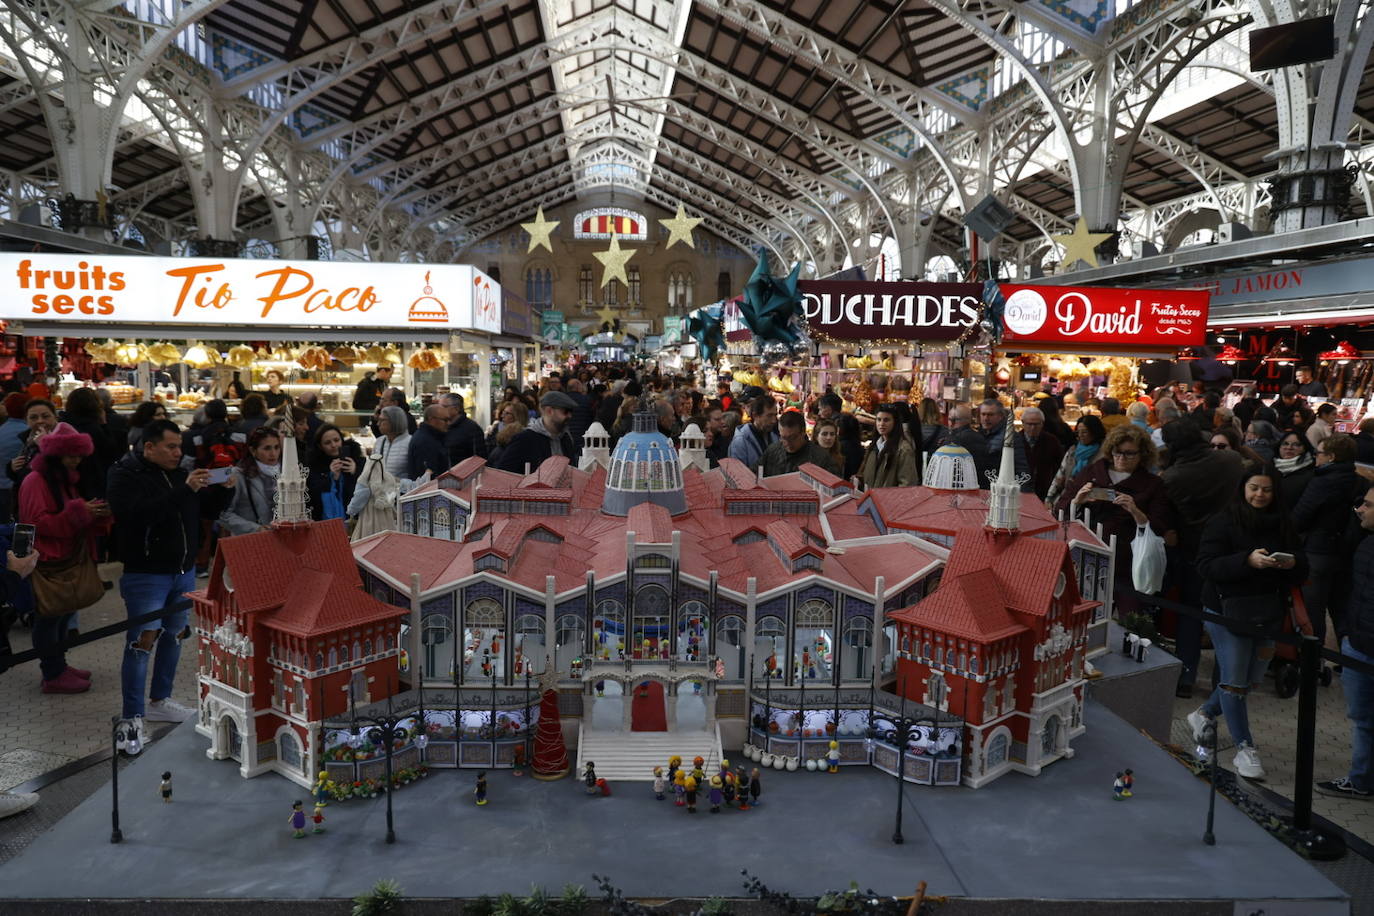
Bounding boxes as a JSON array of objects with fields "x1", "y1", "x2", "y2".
[{"x1": 0, "y1": 253, "x2": 502, "y2": 332}]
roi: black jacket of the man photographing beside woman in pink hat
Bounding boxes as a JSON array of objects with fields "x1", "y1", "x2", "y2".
[{"x1": 106, "y1": 452, "x2": 200, "y2": 575}]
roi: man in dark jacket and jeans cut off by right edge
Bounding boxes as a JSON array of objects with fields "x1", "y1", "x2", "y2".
[{"x1": 1316, "y1": 488, "x2": 1374, "y2": 799}]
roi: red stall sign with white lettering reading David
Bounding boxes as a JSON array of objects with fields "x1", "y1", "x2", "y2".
[{"x1": 1002, "y1": 283, "x2": 1209, "y2": 350}]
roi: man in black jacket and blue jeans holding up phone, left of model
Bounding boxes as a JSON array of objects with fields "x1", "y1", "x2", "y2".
[{"x1": 106, "y1": 420, "x2": 210, "y2": 753}]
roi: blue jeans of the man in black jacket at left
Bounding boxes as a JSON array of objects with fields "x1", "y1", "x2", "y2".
[{"x1": 120, "y1": 569, "x2": 195, "y2": 718}]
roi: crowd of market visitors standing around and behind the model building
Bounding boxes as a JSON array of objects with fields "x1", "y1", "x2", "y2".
[{"x1": 0, "y1": 367, "x2": 1374, "y2": 818}]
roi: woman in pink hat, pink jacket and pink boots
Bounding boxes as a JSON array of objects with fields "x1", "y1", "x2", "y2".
[{"x1": 19, "y1": 423, "x2": 113, "y2": 694}]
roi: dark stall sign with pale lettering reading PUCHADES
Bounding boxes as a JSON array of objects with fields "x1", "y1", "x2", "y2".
[{"x1": 797, "y1": 280, "x2": 982, "y2": 341}]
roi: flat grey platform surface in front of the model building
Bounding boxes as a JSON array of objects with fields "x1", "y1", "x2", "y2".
[{"x1": 0, "y1": 703, "x2": 1348, "y2": 916}]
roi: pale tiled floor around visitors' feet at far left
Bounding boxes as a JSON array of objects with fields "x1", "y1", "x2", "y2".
[{"x1": 0, "y1": 564, "x2": 195, "y2": 788}]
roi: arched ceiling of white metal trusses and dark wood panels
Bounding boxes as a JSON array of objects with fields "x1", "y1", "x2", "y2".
[{"x1": 0, "y1": 0, "x2": 1374, "y2": 276}]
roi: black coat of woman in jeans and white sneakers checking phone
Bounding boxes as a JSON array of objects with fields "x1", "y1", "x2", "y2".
[{"x1": 1197, "y1": 511, "x2": 1308, "y2": 612}]
